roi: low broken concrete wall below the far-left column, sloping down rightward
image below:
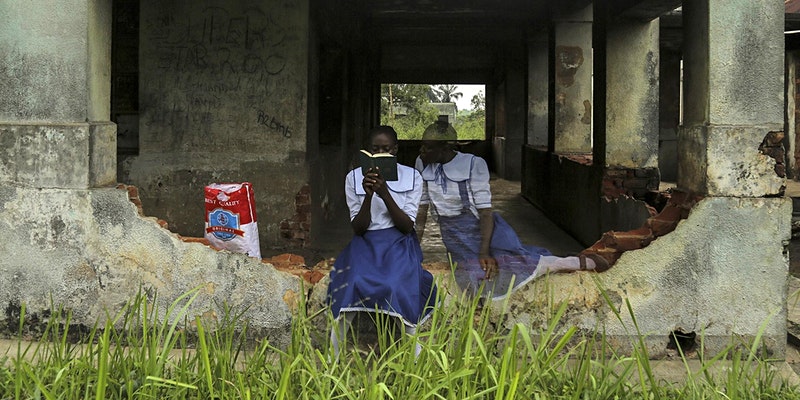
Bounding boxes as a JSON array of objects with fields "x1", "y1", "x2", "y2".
[{"x1": 0, "y1": 185, "x2": 302, "y2": 344}]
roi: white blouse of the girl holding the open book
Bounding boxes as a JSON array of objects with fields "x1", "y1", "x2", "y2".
[{"x1": 344, "y1": 164, "x2": 422, "y2": 231}]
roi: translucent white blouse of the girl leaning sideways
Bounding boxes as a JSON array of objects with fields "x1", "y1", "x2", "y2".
[{"x1": 415, "y1": 151, "x2": 492, "y2": 217}]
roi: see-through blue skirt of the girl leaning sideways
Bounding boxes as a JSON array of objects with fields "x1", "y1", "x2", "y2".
[{"x1": 438, "y1": 212, "x2": 552, "y2": 299}]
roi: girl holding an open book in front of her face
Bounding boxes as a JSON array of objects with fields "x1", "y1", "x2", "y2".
[{"x1": 328, "y1": 126, "x2": 436, "y2": 357}]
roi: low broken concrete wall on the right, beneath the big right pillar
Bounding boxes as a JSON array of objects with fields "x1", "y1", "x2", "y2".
[{"x1": 496, "y1": 198, "x2": 792, "y2": 359}]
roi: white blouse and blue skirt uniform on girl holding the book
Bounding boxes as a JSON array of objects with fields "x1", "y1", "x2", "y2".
[{"x1": 328, "y1": 165, "x2": 436, "y2": 326}]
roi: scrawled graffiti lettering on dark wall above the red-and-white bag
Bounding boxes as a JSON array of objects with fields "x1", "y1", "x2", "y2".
[{"x1": 142, "y1": 5, "x2": 297, "y2": 149}]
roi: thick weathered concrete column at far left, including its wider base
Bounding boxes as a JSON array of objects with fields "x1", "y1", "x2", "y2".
[{"x1": 0, "y1": 0, "x2": 116, "y2": 189}]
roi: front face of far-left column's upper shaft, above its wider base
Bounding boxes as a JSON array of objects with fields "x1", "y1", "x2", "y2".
[{"x1": 0, "y1": 0, "x2": 95, "y2": 122}]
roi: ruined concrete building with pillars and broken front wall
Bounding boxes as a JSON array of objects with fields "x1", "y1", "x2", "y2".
[{"x1": 0, "y1": 0, "x2": 800, "y2": 359}]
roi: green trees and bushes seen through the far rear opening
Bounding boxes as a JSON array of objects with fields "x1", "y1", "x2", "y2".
[{"x1": 381, "y1": 83, "x2": 486, "y2": 140}]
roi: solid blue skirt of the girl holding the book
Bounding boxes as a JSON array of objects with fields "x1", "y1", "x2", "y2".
[{"x1": 328, "y1": 228, "x2": 436, "y2": 326}]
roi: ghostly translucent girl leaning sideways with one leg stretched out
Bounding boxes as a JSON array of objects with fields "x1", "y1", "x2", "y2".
[{"x1": 415, "y1": 121, "x2": 609, "y2": 299}]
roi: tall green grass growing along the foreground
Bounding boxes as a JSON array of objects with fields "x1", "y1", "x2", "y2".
[{"x1": 0, "y1": 280, "x2": 800, "y2": 400}]
